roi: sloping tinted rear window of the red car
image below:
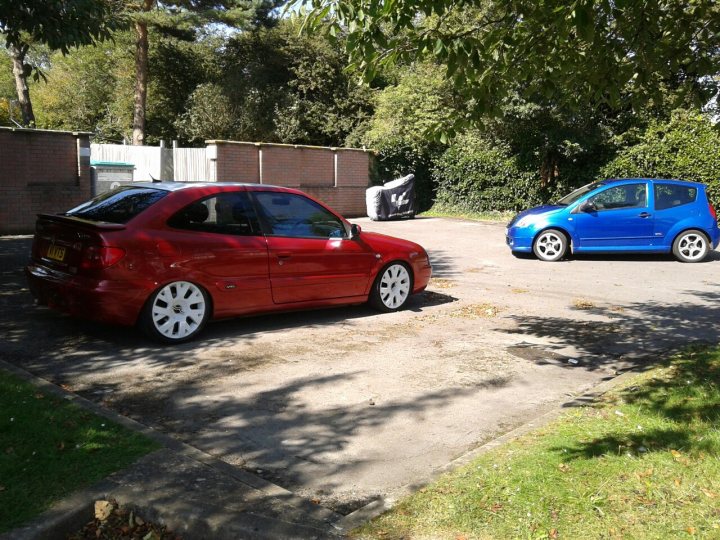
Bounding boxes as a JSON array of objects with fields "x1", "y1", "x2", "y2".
[{"x1": 65, "y1": 186, "x2": 168, "y2": 223}]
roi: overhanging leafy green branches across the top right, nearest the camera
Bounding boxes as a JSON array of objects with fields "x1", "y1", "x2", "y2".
[{"x1": 297, "y1": 0, "x2": 720, "y2": 133}]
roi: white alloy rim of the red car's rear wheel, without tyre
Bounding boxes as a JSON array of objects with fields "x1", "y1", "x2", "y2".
[{"x1": 151, "y1": 281, "x2": 207, "y2": 340}]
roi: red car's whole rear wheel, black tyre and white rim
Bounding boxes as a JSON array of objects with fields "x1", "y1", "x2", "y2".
[{"x1": 140, "y1": 281, "x2": 212, "y2": 343}]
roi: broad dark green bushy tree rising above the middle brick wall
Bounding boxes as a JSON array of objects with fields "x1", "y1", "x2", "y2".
[{"x1": 176, "y1": 19, "x2": 372, "y2": 146}]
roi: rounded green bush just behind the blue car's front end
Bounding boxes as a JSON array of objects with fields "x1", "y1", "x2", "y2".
[{"x1": 433, "y1": 133, "x2": 547, "y2": 212}]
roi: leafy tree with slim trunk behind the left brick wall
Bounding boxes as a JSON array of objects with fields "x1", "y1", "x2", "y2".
[{"x1": 0, "y1": 0, "x2": 120, "y2": 126}]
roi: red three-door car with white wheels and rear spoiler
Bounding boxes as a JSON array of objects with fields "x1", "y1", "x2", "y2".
[{"x1": 26, "y1": 182, "x2": 432, "y2": 343}]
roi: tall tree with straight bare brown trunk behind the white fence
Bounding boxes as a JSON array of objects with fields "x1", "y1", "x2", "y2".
[{"x1": 125, "y1": 0, "x2": 282, "y2": 145}]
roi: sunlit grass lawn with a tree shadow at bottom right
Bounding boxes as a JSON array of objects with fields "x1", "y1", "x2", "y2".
[{"x1": 354, "y1": 349, "x2": 720, "y2": 539}]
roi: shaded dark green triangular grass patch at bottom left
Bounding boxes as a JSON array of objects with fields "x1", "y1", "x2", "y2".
[{"x1": 0, "y1": 371, "x2": 158, "y2": 533}]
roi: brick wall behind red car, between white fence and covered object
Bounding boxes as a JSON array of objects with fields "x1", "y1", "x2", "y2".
[{"x1": 207, "y1": 141, "x2": 372, "y2": 217}]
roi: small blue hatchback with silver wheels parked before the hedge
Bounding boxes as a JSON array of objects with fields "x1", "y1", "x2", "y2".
[{"x1": 506, "y1": 178, "x2": 720, "y2": 262}]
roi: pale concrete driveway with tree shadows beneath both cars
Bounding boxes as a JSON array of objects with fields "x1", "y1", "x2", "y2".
[{"x1": 0, "y1": 218, "x2": 720, "y2": 513}]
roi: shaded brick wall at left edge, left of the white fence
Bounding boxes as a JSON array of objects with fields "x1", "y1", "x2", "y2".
[{"x1": 0, "y1": 127, "x2": 90, "y2": 234}]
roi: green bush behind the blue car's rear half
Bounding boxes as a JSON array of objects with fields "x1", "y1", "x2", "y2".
[{"x1": 602, "y1": 110, "x2": 720, "y2": 201}]
